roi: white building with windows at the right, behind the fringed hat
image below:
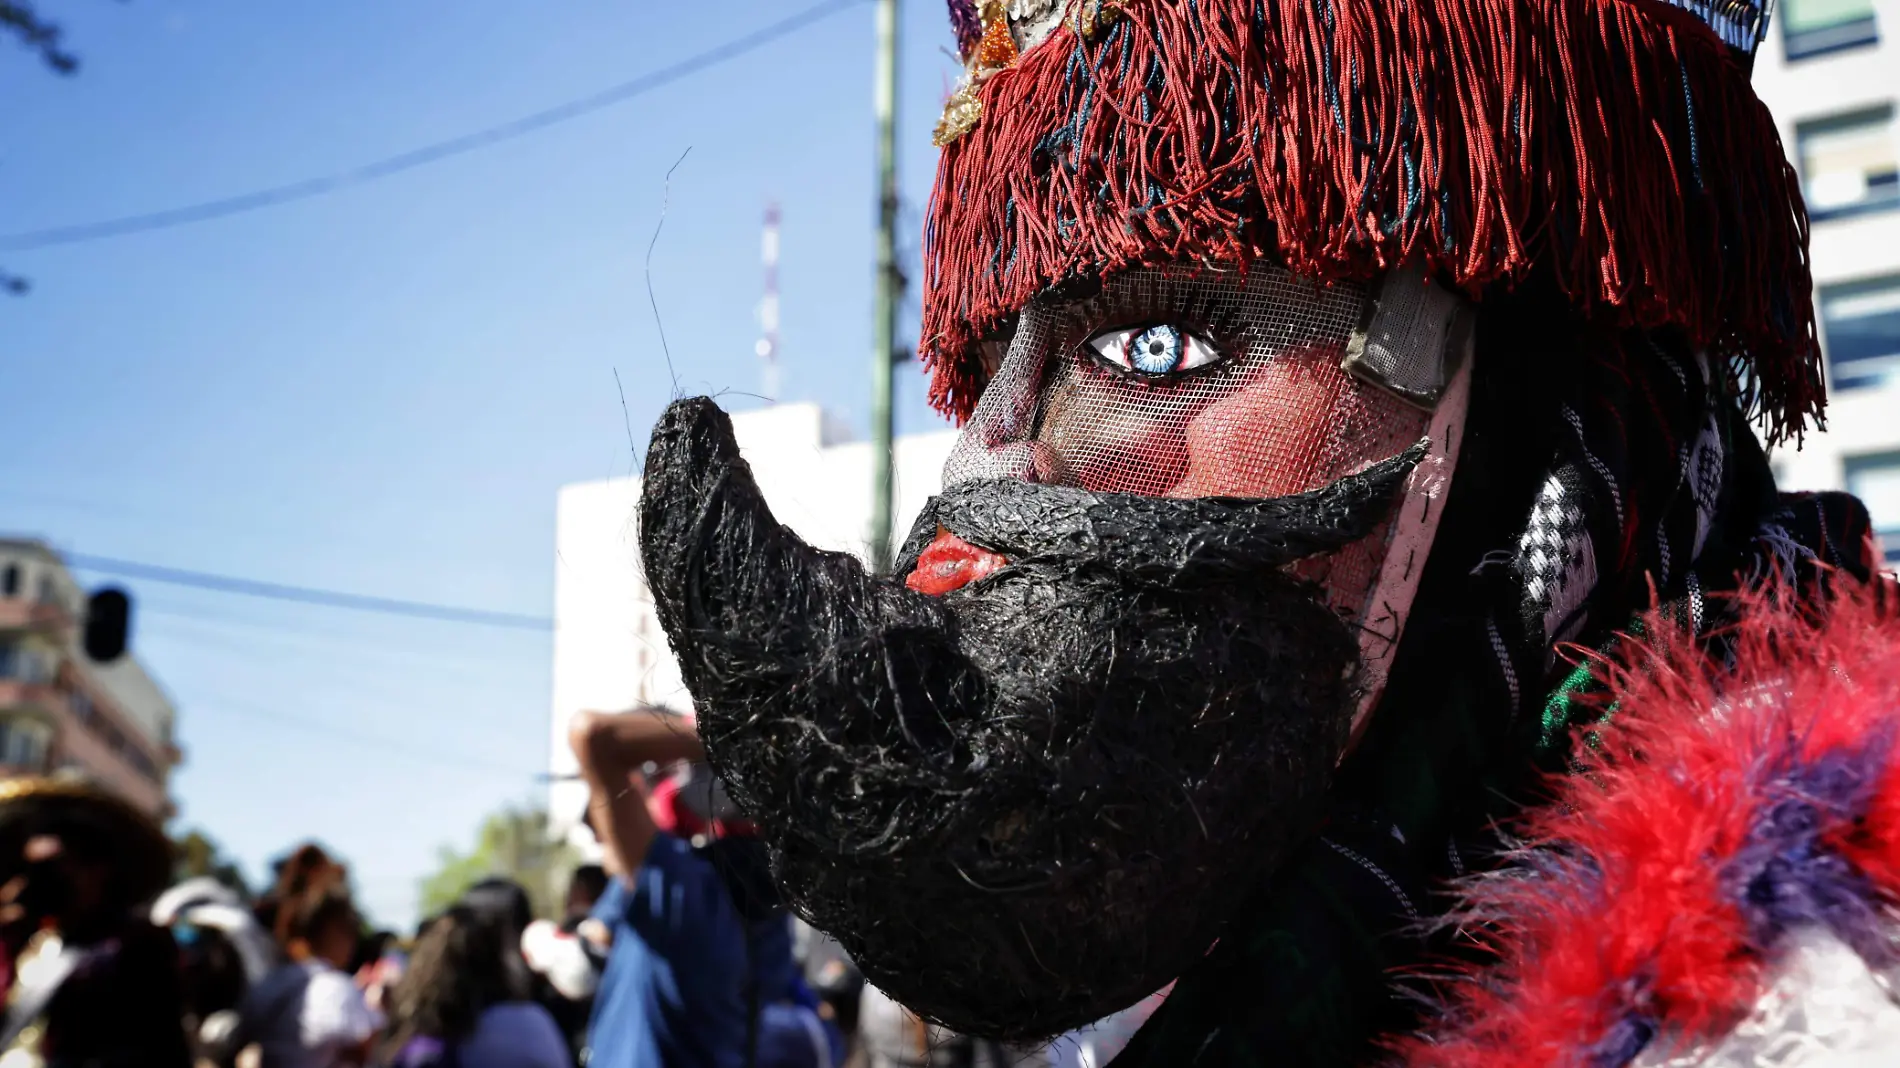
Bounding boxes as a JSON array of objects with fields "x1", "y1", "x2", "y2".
[{"x1": 1754, "y1": 0, "x2": 1900, "y2": 564}]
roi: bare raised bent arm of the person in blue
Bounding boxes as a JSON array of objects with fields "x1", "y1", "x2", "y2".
[{"x1": 568, "y1": 709, "x2": 705, "y2": 880}]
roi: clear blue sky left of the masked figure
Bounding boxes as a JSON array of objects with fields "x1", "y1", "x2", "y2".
[{"x1": 0, "y1": 0, "x2": 956, "y2": 924}]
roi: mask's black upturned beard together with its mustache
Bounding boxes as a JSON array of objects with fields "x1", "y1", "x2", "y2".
[{"x1": 640, "y1": 399, "x2": 1421, "y2": 1039}]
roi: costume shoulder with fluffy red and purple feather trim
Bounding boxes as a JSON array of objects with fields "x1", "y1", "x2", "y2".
[{"x1": 1398, "y1": 582, "x2": 1900, "y2": 1068}]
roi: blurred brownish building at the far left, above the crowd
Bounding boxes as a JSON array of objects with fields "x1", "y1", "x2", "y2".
[{"x1": 0, "y1": 538, "x2": 182, "y2": 819}]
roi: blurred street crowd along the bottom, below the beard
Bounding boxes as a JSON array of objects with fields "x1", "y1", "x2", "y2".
[{"x1": 0, "y1": 711, "x2": 1153, "y2": 1068}]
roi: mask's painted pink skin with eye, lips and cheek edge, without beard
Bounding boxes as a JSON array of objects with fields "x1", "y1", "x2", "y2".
[{"x1": 931, "y1": 266, "x2": 1469, "y2": 741}]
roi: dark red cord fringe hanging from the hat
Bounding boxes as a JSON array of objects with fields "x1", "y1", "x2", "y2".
[{"x1": 920, "y1": 0, "x2": 1824, "y2": 439}]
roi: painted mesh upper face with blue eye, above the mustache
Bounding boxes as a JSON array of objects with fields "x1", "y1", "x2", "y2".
[{"x1": 944, "y1": 266, "x2": 1438, "y2": 498}]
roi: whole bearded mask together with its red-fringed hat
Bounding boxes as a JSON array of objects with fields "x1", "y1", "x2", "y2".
[{"x1": 640, "y1": 0, "x2": 1822, "y2": 1039}]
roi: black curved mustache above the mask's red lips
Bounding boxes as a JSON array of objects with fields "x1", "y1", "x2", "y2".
[{"x1": 899, "y1": 441, "x2": 1427, "y2": 587}]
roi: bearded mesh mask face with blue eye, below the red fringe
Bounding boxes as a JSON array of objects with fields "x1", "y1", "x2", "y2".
[{"x1": 640, "y1": 264, "x2": 1469, "y2": 1039}]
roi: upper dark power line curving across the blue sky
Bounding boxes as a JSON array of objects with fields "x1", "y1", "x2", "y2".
[{"x1": 0, "y1": 0, "x2": 865, "y2": 251}]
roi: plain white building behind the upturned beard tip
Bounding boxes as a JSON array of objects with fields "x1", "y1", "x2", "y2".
[{"x1": 547, "y1": 405, "x2": 956, "y2": 851}]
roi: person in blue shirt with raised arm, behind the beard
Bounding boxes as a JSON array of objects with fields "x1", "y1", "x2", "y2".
[{"x1": 570, "y1": 709, "x2": 842, "y2": 1068}]
